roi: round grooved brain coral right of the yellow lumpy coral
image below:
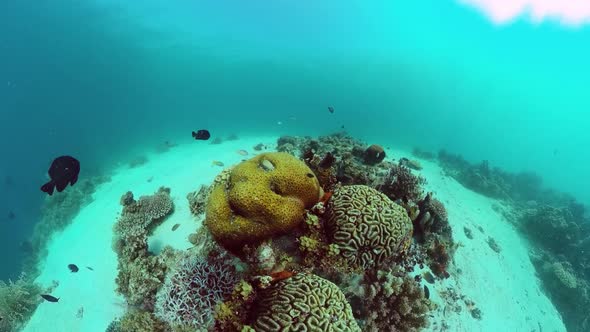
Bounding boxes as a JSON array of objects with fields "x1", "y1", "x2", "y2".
[{"x1": 326, "y1": 185, "x2": 413, "y2": 268}]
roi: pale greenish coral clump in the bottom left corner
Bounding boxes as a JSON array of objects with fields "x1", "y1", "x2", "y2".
[{"x1": 0, "y1": 275, "x2": 43, "y2": 332}]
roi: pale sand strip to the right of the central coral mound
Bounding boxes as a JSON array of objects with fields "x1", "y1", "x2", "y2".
[{"x1": 391, "y1": 150, "x2": 566, "y2": 332}]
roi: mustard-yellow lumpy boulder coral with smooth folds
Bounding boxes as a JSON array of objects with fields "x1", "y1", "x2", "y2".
[{"x1": 205, "y1": 152, "x2": 322, "y2": 251}]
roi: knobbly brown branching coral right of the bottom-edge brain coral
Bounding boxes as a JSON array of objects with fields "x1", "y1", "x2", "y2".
[{"x1": 361, "y1": 266, "x2": 434, "y2": 332}]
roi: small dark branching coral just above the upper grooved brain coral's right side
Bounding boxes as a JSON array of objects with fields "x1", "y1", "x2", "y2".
[{"x1": 378, "y1": 165, "x2": 426, "y2": 202}]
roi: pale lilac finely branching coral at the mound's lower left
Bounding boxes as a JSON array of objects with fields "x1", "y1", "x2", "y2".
[{"x1": 155, "y1": 255, "x2": 238, "y2": 329}]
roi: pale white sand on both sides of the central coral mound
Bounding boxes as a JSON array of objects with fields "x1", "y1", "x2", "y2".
[{"x1": 24, "y1": 137, "x2": 565, "y2": 332}]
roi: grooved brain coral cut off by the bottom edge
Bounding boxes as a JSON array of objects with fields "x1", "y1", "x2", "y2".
[{"x1": 252, "y1": 273, "x2": 360, "y2": 332}]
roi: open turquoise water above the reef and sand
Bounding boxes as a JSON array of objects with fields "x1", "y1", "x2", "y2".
[{"x1": 0, "y1": 0, "x2": 590, "y2": 330}]
